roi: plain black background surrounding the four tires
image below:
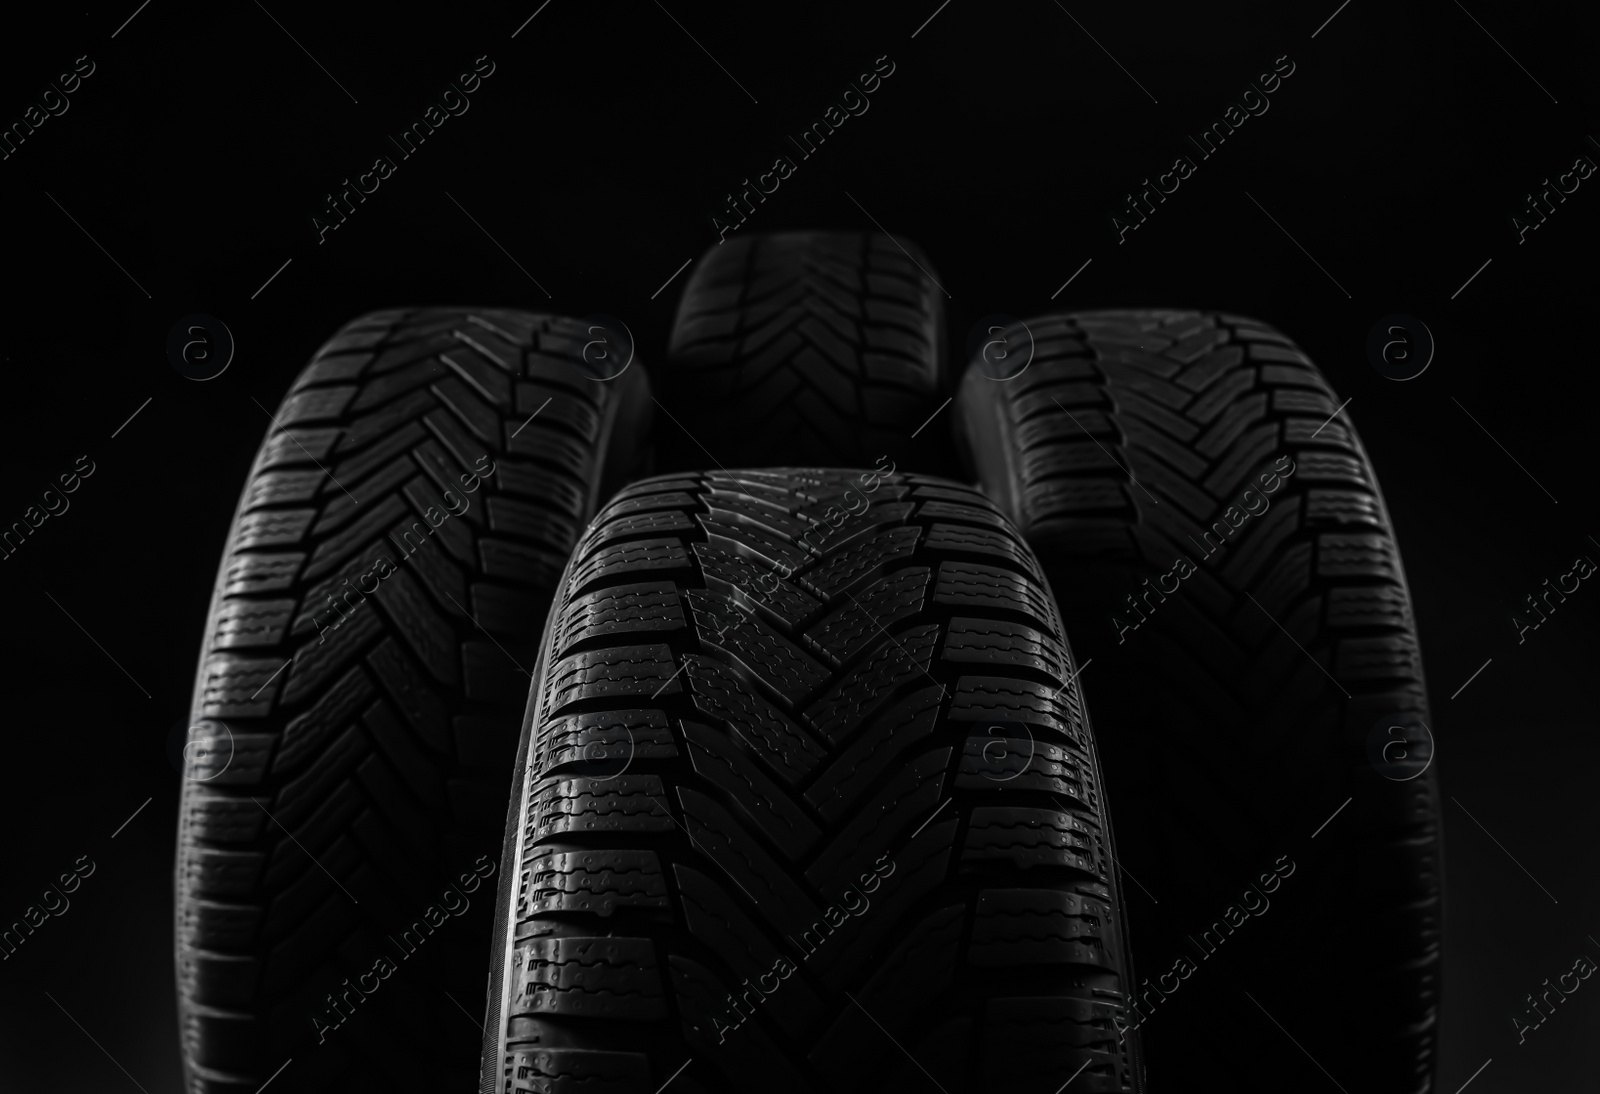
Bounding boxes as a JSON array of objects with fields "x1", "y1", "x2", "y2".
[{"x1": 0, "y1": 0, "x2": 1600, "y2": 1092}]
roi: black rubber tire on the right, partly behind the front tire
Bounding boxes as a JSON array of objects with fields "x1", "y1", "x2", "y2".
[{"x1": 954, "y1": 310, "x2": 1442, "y2": 1092}]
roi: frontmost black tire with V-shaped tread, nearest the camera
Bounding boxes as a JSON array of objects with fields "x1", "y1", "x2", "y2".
[{"x1": 480, "y1": 469, "x2": 1142, "y2": 1094}]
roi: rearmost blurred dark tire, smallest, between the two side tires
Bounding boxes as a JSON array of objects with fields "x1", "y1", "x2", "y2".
[{"x1": 658, "y1": 232, "x2": 954, "y2": 472}]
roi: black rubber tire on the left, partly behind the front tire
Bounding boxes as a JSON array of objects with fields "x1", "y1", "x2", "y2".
[{"x1": 174, "y1": 309, "x2": 650, "y2": 1094}]
